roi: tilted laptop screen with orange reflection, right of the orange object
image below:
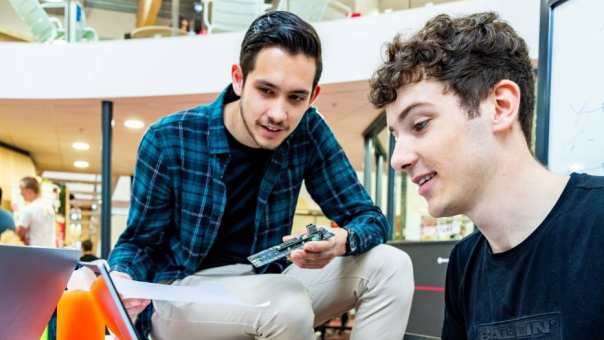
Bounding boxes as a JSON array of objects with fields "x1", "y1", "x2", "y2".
[{"x1": 80, "y1": 260, "x2": 140, "y2": 340}]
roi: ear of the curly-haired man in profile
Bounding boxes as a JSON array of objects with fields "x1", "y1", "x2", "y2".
[{"x1": 491, "y1": 79, "x2": 521, "y2": 133}]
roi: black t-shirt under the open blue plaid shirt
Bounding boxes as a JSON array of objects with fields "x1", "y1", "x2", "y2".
[{"x1": 200, "y1": 126, "x2": 272, "y2": 269}]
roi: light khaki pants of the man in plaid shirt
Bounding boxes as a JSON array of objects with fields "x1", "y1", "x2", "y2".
[{"x1": 151, "y1": 245, "x2": 414, "y2": 340}]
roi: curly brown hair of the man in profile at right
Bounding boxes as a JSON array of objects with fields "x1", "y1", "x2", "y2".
[{"x1": 369, "y1": 12, "x2": 535, "y2": 145}]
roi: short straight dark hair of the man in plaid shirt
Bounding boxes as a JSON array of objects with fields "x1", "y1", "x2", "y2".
[{"x1": 239, "y1": 11, "x2": 323, "y2": 89}]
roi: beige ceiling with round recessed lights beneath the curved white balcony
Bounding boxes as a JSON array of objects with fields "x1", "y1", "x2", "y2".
[{"x1": 0, "y1": 81, "x2": 378, "y2": 176}]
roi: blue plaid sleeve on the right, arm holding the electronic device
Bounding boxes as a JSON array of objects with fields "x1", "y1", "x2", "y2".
[{"x1": 304, "y1": 114, "x2": 389, "y2": 255}]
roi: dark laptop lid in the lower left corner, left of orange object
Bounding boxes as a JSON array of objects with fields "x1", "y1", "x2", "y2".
[{"x1": 0, "y1": 245, "x2": 80, "y2": 340}]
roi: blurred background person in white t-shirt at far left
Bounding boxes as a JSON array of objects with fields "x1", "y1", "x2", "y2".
[{"x1": 17, "y1": 177, "x2": 55, "y2": 247}]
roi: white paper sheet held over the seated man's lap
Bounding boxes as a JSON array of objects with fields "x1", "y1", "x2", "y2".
[{"x1": 112, "y1": 277, "x2": 270, "y2": 307}]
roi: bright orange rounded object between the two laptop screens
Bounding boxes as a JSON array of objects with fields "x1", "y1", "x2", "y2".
[{"x1": 57, "y1": 290, "x2": 105, "y2": 340}]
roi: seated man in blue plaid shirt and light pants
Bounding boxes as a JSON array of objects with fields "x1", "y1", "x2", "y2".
[{"x1": 110, "y1": 12, "x2": 413, "y2": 340}]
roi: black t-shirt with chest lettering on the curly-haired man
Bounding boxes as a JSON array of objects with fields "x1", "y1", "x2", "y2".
[{"x1": 442, "y1": 174, "x2": 604, "y2": 340}]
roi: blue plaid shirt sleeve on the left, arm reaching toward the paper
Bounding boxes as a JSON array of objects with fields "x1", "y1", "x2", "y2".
[{"x1": 109, "y1": 126, "x2": 173, "y2": 281}]
